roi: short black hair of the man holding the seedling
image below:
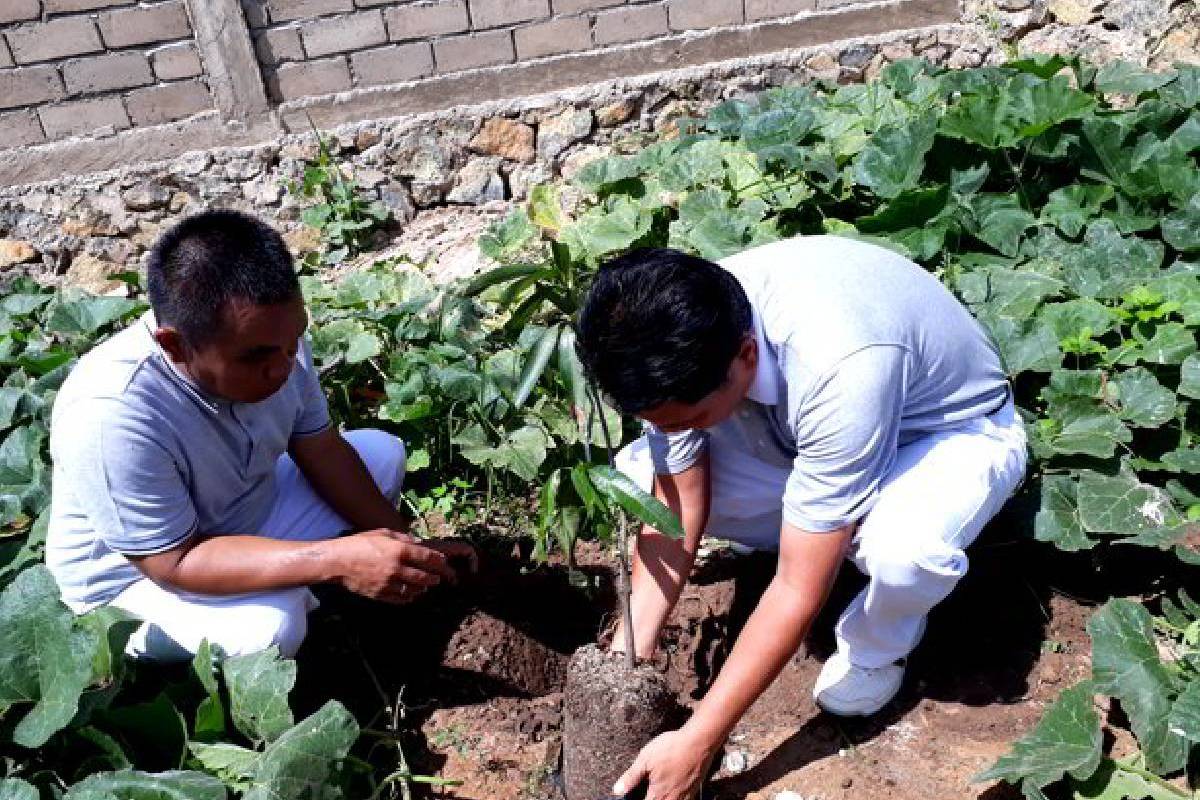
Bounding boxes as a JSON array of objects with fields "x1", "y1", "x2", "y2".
[{"x1": 576, "y1": 247, "x2": 752, "y2": 414}]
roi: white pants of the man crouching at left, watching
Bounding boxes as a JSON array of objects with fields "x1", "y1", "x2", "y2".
[{"x1": 112, "y1": 429, "x2": 404, "y2": 661}]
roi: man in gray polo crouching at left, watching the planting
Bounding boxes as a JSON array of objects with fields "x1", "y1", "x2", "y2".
[{"x1": 46, "y1": 211, "x2": 474, "y2": 661}]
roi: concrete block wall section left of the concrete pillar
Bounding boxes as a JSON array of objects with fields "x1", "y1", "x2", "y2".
[{"x1": 0, "y1": 0, "x2": 214, "y2": 149}]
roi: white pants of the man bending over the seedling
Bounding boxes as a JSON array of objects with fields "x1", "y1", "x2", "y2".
[{"x1": 617, "y1": 402, "x2": 1026, "y2": 667}]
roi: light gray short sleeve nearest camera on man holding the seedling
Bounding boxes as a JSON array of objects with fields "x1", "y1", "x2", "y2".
[{"x1": 784, "y1": 345, "x2": 907, "y2": 533}]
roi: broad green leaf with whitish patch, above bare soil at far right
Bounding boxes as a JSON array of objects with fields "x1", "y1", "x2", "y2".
[{"x1": 1079, "y1": 471, "x2": 1181, "y2": 536}]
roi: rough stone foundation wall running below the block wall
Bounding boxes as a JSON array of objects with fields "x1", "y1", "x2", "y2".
[{"x1": 0, "y1": 0, "x2": 1200, "y2": 290}]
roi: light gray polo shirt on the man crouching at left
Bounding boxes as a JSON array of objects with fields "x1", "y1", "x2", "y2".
[{"x1": 46, "y1": 314, "x2": 330, "y2": 612}]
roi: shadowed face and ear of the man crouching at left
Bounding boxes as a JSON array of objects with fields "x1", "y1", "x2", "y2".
[{"x1": 155, "y1": 296, "x2": 308, "y2": 403}]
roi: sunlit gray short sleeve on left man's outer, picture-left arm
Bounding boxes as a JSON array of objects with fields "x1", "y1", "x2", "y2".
[{"x1": 54, "y1": 404, "x2": 199, "y2": 555}]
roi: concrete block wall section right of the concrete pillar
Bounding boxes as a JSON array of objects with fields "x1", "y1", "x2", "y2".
[{"x1": 241, "y1": 0, "x2": 871, "y2": 103}]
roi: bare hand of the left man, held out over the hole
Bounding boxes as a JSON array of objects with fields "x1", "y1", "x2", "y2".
[{"x1": 336, "y1": 528, "x2": 457, "y2": 603}]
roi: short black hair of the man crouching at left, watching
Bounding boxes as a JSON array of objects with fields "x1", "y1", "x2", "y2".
[{"x1": 146, "y1": 210, "x2": 300, "y2": 344}]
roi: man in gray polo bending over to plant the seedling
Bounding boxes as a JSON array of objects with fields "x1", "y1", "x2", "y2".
[{"x1": 578, "y1": 236, "x2": 1026, "y2": 800}]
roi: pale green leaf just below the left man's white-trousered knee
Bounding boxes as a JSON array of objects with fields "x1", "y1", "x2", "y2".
[{"x1": 221, "y1": 646, "x2": 296, "y2": 742}]
